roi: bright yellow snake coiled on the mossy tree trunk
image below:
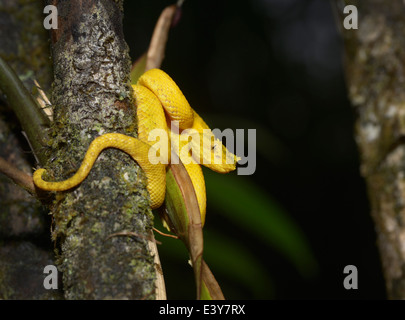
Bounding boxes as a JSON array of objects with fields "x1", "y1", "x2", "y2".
[{"x1": 33, "y1": 69, "x2": 240, "y2": 224}]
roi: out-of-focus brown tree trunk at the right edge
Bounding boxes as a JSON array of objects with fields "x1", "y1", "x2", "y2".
[{"x1": 336, "y1": 0, "x2": 405, "y2": 299}]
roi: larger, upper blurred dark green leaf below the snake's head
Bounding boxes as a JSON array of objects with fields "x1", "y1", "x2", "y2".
[{"x1": 204, "y1": 170, "x2": 317, "y2": 277}]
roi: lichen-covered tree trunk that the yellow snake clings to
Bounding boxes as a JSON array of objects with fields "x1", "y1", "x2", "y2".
[{"x1": 46, "y1": 0, "x2": 156, "y2": 299}]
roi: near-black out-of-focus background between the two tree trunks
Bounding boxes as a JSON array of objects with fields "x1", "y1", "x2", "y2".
[{"x1": 124, "y1": 0, "x2": 386, "y2": 299}]
